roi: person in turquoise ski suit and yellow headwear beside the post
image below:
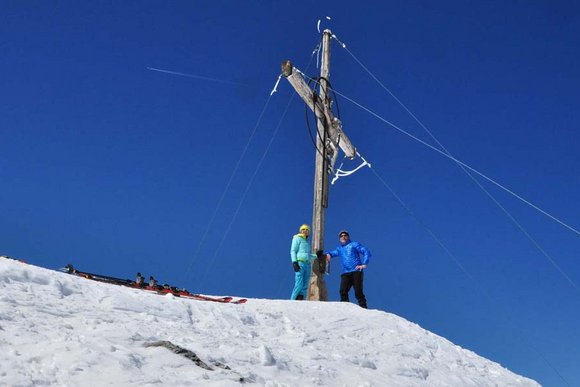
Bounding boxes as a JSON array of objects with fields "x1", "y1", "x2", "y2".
[{"x1": 290, "y1": 224, "x2": 314, "y2": 300}]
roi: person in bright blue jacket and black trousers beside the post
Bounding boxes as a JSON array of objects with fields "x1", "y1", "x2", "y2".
[{"x1": 326, "y1": 230, "x2": 371, "y2": 308}]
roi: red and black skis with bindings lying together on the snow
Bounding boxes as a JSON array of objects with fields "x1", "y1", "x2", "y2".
[{"x1": 61, "y1": 264, "x2": 248, "y2": 304}]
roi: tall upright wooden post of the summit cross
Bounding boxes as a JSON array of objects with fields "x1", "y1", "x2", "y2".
[{"x1": 308, "y1": 30, "x2": 332, "y2": 301}]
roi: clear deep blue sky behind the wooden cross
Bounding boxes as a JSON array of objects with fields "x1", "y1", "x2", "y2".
[{"x1": 0, "y1": 1, "x2": 580, "y2": 386}]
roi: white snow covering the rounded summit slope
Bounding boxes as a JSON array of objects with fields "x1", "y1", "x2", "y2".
[{"x1": 0, "y1": 259, "x2": 539, "y2": 387}]
